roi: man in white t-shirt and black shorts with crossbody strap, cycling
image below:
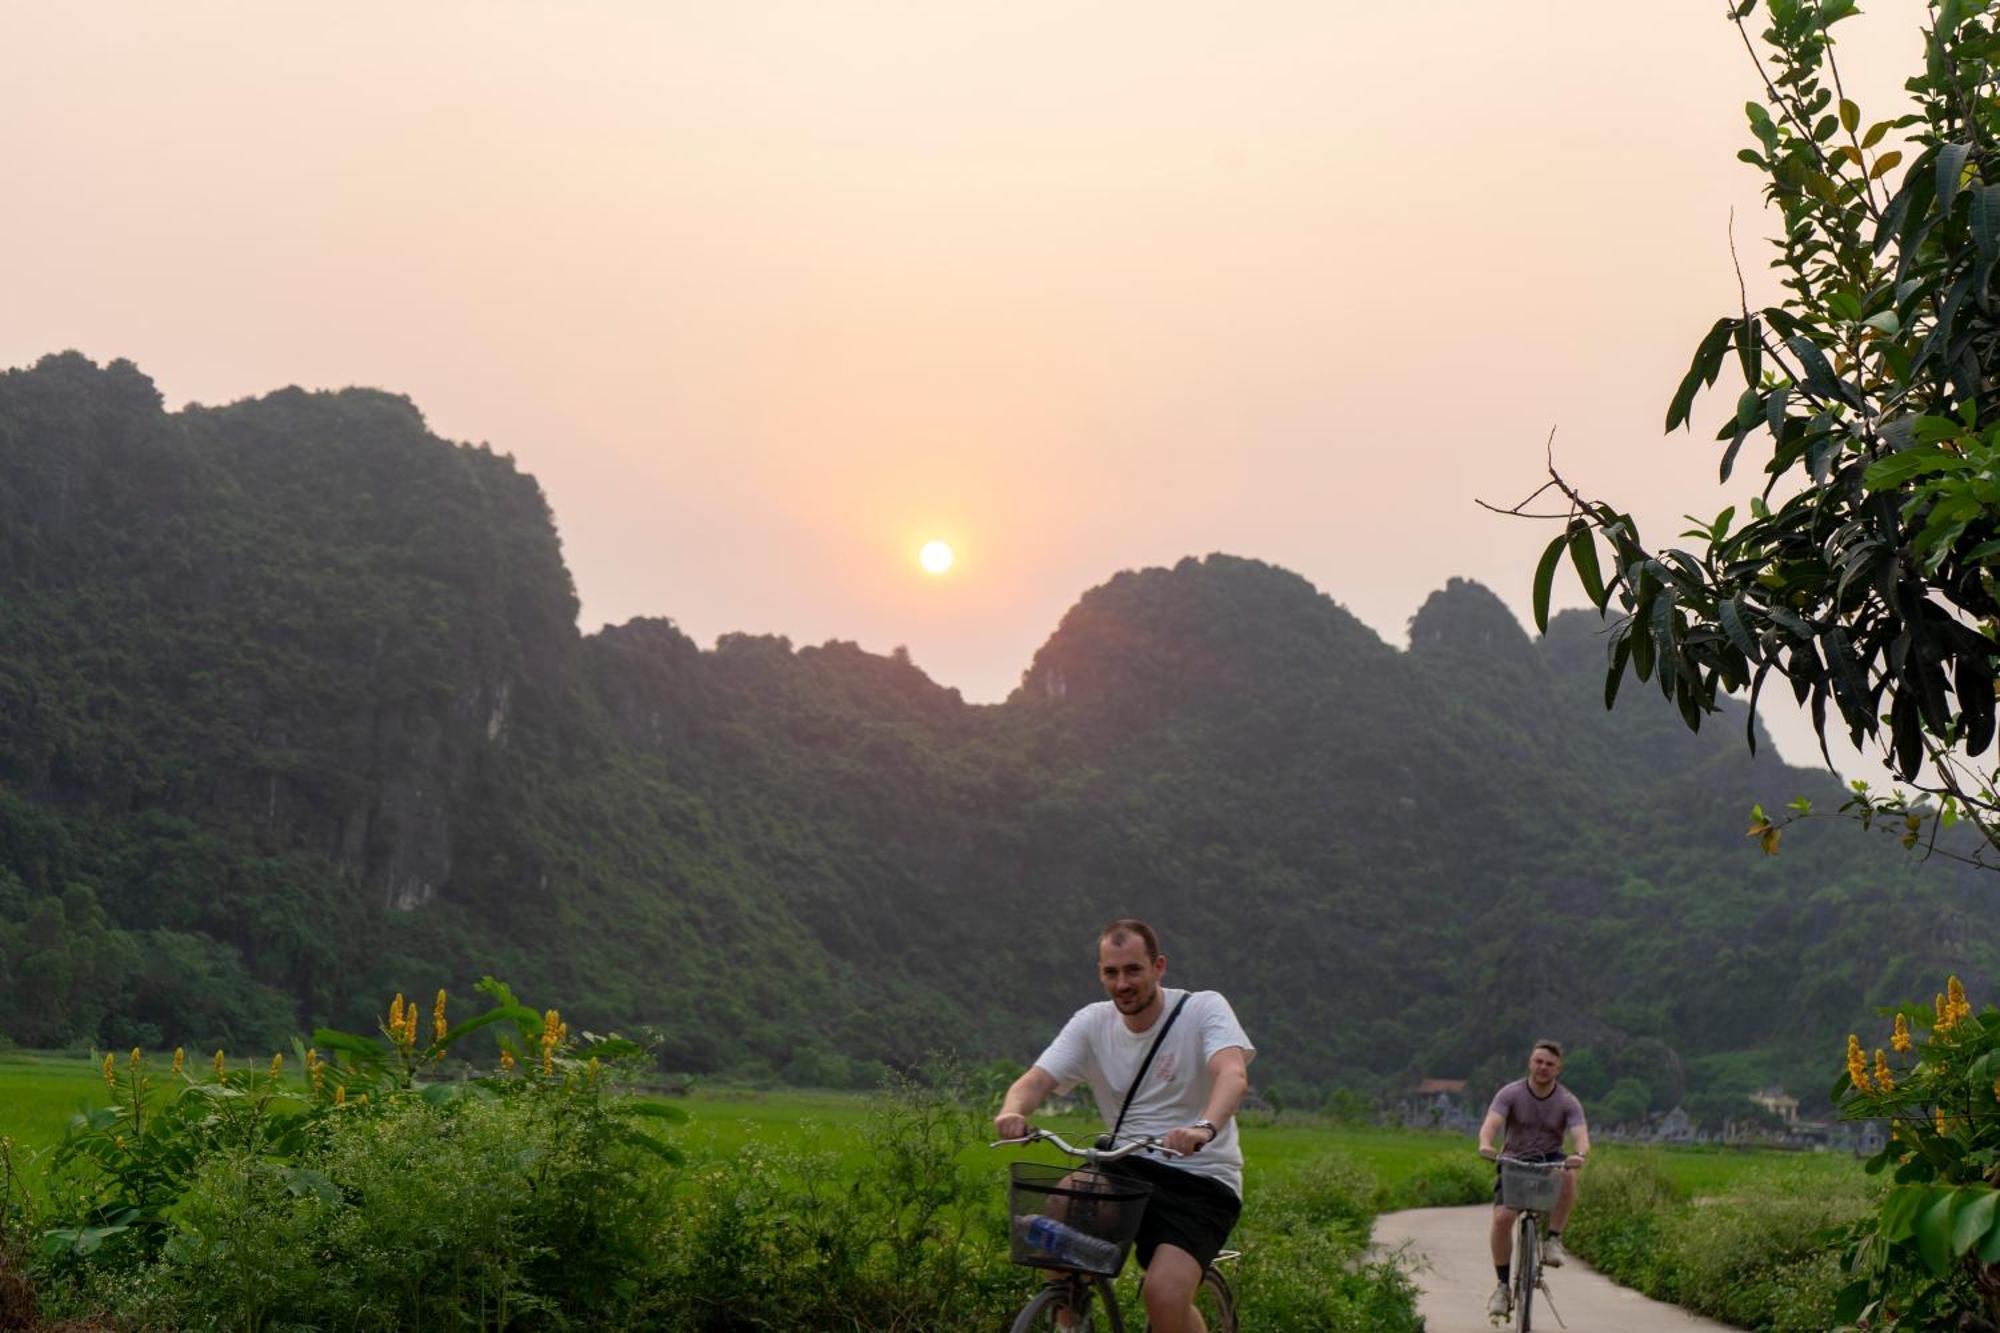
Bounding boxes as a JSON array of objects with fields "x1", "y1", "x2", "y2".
[{"x1": 994, "y1": 919, "x2": 1256, "y2": 1333}]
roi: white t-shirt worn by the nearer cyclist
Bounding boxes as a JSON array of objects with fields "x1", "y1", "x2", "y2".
[{"x1": 1034, "y1": 987, "x2": 1256, "y2": 1199}]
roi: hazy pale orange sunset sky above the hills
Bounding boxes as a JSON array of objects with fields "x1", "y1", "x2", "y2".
[{"x1": 0, "y1": 0, "x2": 1924, "y2": 761}]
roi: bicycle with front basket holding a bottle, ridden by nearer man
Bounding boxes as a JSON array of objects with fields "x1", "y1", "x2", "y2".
[{"x1": 992, "y1": 1129, "x2": 1240, "y2": 1333}]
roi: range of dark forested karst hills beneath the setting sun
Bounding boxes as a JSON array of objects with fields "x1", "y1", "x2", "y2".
[{"x1": 0, "y1": 354, "x2": 2000, "y2": 1107}]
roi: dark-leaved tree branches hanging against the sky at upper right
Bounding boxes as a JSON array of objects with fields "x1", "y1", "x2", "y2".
[{"x1": 1536, "y1": 0, "x2": 2000, "y2": 867}]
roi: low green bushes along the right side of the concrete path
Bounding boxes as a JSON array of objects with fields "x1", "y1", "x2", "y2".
[{"x1": 1564, "y1": 1159, "x2": 1876, "y2": 1333}]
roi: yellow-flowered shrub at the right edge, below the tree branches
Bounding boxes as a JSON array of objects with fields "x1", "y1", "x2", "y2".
[{"x1": 1832, "y1": 977, "x2": 2000, "y2": 1329}]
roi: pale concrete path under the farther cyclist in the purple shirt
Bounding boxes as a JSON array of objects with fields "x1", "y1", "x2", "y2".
[{"x1": 1374, "y1": 1205, "x2": 1730, "y2": 1333}]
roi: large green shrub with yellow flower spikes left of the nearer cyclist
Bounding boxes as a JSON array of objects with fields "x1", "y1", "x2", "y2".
[{"x1": 34, "y1": 979, "x2": 686, "y2": 1327}]
